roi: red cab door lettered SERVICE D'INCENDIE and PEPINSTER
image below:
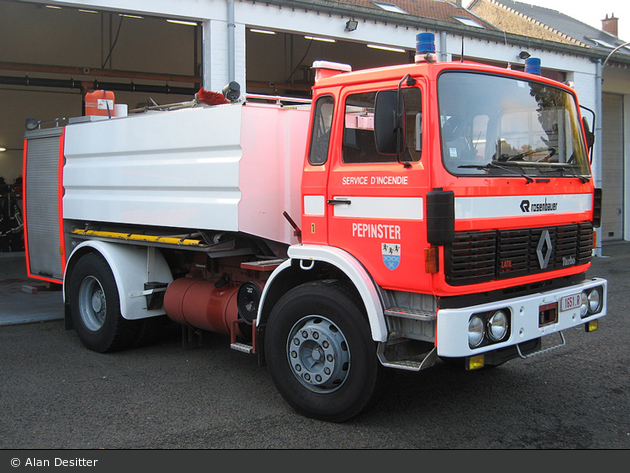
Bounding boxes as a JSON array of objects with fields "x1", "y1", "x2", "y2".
[{"x1": 326, "y1": 87, "x2": 428, "y2": 289}]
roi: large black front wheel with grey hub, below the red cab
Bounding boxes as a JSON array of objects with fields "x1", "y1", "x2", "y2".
[{"x1": 265, "y1": 281, "x2": 384, "y2": 422}]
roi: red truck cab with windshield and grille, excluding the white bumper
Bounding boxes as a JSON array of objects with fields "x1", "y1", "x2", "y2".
[{"x1": 302, "y1": 57, "x2": 597, "y2": 296}]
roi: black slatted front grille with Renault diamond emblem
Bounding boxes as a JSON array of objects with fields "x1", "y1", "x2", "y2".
[{"x1": 445, "y1": 222, "x2": 593, "y2": 286}]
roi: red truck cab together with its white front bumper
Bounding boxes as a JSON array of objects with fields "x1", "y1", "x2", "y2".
[{"x1": 302, "y1": 34, "x2": 606, "y2": 368}]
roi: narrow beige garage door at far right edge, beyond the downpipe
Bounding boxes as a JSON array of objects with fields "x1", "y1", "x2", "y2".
[{"x1": 602, "y1": 94, "x2": 624, "y2": 241}]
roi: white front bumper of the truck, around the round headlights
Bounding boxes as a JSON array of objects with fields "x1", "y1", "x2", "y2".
[{"x1": 437, "y1": 278, "x2": 608, "y2": 358}]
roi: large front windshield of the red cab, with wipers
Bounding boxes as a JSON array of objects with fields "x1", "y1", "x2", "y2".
[{"x1": 438, "y1": 71, "x2": 590, "y2": 180}]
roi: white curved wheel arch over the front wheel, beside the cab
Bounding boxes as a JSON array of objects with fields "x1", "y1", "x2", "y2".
[{"x1": 257, "y1": 245, "x2": 388, "y2": 342}]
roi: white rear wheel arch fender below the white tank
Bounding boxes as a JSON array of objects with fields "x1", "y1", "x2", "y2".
[{"x1": 63, "y1": 240, "x2": 173, "y2": 320}]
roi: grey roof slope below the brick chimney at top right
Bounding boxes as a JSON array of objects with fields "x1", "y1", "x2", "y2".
[{"x1": 469, "y1": 0, "x2": 630, "y2": 60}]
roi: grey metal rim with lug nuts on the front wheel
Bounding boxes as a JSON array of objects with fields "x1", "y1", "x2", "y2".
[{"x1": 287, "y1": 315, "x2": 350, "y2": 393}]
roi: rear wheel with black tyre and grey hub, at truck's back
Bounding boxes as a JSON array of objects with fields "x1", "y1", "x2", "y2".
[{"x1": 68, "y1": 253, "x2": 140, "y2": 353}]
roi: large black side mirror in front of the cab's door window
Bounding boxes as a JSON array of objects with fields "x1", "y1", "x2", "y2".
[{"x1": 374, "y1": 90, "x2": 406, "y2": 155}]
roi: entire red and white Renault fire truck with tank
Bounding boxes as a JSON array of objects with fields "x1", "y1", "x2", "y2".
[{"x1": 24, "y1": 33, "x2": 607, "y2": 422}]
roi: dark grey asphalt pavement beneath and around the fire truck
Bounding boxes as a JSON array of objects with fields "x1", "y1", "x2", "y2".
[{"x1": 0, "y1": 242, "x2": 630, "y2": 450}]
